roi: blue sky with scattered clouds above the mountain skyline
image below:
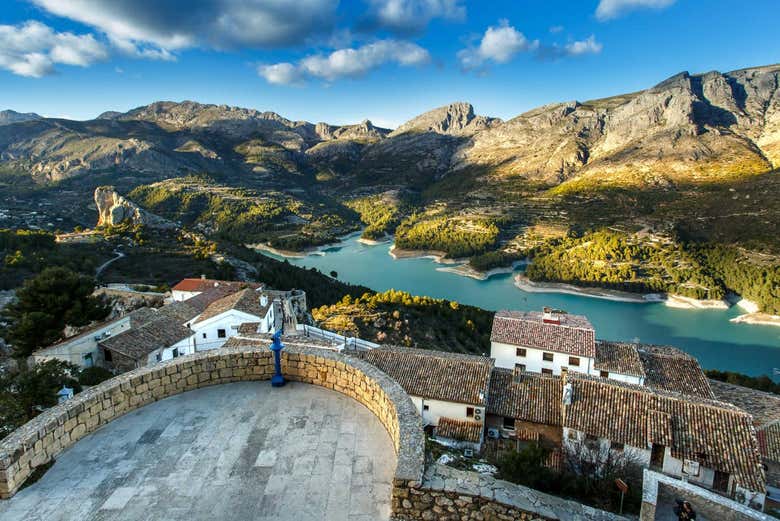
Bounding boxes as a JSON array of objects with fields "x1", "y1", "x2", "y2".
[{"x1": 0, "y1": 0, "x2": 780, "y2": 126}]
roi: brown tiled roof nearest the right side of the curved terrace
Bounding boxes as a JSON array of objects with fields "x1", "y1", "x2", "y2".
[{"x1": 354, "y1": 346, "x2": 493, "y2": 406}]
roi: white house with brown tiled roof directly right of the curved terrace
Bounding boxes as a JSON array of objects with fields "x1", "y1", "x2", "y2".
[{"x1": 355, "y1": 346, "x2": 493, "y2": 449}]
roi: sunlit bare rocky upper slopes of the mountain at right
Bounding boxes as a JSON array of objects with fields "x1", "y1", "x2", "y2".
[{"x1": 455, "y1": 66, "x2": 780, "y2": 182}]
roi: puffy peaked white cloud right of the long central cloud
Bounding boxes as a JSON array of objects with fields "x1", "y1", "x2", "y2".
[{"x1": 458, "y1": 20, "x2": 539, "y2": 70}]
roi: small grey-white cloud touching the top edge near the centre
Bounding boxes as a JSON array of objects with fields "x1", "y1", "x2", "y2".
[{"x1": 369, "y1": 0, "x2": 466, "y2": 33}]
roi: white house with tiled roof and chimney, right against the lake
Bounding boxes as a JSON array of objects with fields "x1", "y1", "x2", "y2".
[{"x1": 490, "y1": 308, "x2": 596, "y2": 375}]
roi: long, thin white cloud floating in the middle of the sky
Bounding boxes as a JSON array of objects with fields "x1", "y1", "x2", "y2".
[{"x1": 258, "y1": 40, "x2": 431, "y2": 85}]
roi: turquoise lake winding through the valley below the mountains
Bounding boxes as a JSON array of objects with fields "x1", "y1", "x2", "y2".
[{"x1": 260, "y1": 234, "x2": 780, "y2": 380}]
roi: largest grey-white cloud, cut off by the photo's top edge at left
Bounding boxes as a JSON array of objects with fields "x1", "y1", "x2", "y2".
[{"x1": 32, "y1": 0, "x2": 338, "y2": 59}]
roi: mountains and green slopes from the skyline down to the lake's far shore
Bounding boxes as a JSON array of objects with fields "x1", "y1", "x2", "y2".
[{"x1": 0, "y1": 65, "x2": 780, "y2": 314}]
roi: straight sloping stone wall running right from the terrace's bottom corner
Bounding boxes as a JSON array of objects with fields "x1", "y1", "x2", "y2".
[{"x1": 393, "y1": 463, "x2": 626, "y2": 521}]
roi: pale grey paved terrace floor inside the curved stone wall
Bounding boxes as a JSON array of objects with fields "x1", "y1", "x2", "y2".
[{"x1": 0, "y1": 382, "x2": 395, "y2": 521}]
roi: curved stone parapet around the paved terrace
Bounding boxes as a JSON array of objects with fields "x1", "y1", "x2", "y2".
[{"x1": 0, "y1": 346, "x2": 425, "y2": 503}]
